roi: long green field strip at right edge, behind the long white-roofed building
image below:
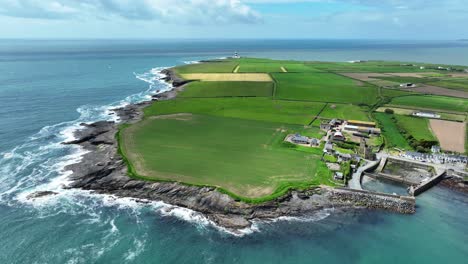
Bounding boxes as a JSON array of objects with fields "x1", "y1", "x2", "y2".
[{"x1": 390, "y1": 95, "x2": 468, "y2": 112}]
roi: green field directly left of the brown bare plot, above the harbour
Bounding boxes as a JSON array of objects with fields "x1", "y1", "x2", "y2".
[{"x1": 395, "y1": 115, "x2": 437, "y2": 141}]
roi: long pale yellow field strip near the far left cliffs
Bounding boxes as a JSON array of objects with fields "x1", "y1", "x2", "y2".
[{"x1": 181, "y1": 73, "x2": 272, "y2": 82}]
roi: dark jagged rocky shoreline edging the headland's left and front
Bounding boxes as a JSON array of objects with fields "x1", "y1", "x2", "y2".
[{"x1": 31, "y1": 67, "x2": 415, "y2": 231}]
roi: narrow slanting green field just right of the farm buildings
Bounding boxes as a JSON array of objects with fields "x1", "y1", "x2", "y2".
[{"x1": 374, "y1": 113, "x2": 411, "y2": 149}]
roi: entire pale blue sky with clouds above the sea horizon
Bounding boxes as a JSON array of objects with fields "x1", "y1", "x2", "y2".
[{"x1": 0, "y1": 0, "x2": 468, "y2": 40}]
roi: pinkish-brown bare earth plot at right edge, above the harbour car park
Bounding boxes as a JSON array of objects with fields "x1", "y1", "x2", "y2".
[{"x1": 430, "y1": 119, "x2": 466, "y2": 153}]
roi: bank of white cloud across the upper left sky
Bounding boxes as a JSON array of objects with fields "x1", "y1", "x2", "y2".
[{"x1": 0, "y1": 0, "x2": 261, "y2": 23}]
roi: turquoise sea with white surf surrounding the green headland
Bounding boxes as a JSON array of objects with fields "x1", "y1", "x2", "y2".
[{"x1": 0, "y1": 40, "x2": 468, "y2": 263}]
